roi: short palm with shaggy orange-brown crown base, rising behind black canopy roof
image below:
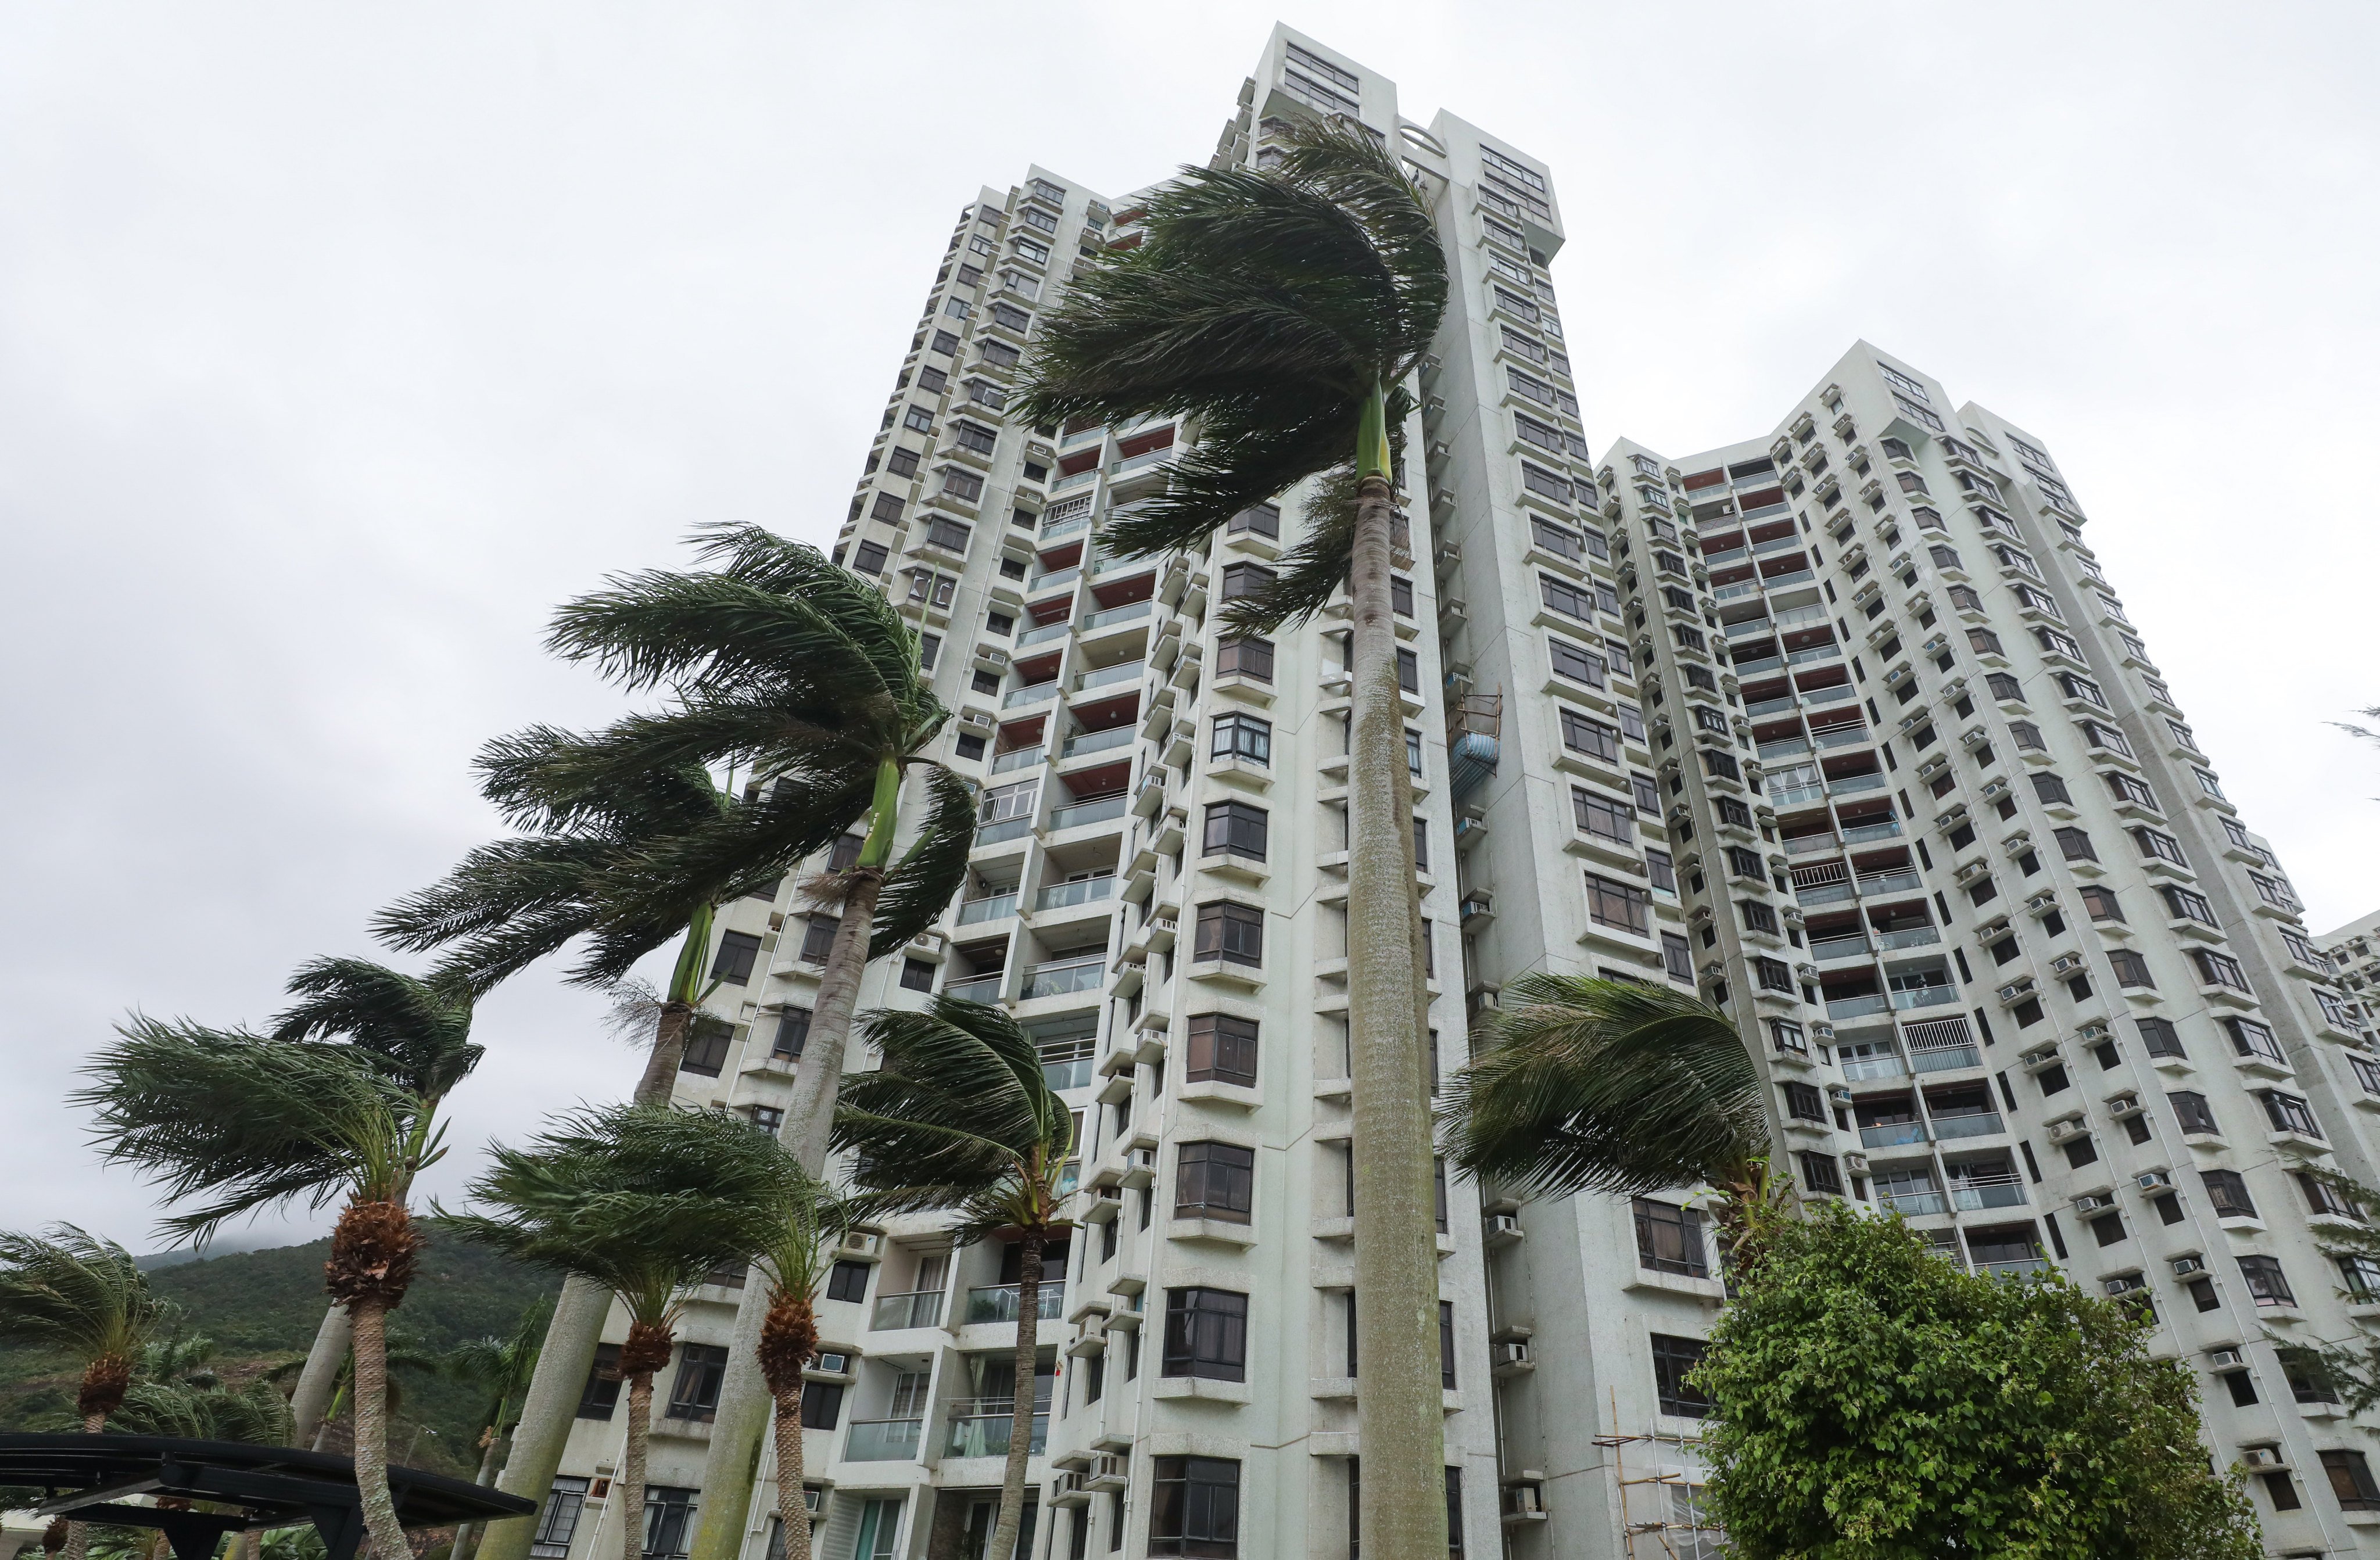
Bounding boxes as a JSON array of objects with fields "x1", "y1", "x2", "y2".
[{"x1": 71, "y1": 958, "x2": 481, "y2": 1555}]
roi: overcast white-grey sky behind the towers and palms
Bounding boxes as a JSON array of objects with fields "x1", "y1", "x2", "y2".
[{"x1": 0, "y1": 0, "x2": 2380, "y2": 1249}]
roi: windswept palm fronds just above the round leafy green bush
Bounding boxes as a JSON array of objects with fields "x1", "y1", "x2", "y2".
[{"x1": 1440, "y1": 975, "x2": 1768, "y2": 1210}]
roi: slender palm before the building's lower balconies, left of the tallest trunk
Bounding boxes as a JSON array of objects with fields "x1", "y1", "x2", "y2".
[{"x1": 836, "y1": 996, "x2": 1073, "y2": 1560}]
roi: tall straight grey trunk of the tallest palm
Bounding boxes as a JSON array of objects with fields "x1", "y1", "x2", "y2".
[{"x1": 1347, "y1": 411, "x2": 1447, "y2": 1560}]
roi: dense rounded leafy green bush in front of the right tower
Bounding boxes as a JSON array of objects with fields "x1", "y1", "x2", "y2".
[{"x1": 1694, "y1": 1201, "x2": 2263, "y2": 1560}]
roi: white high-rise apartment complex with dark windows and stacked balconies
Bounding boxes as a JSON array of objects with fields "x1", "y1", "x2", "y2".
[{"x1": 516, "y1": 28, "x2": 2380, "y2": 1560}]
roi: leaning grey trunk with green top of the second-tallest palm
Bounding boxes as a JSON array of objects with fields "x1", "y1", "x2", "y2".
[{"x1": 695, "y1": 804, "x2": 899, "y2": 1560}]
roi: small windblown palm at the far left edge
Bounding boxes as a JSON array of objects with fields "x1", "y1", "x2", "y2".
[{"x1": 0, "y1": 1225, "x2": 167, "y2": 1560}]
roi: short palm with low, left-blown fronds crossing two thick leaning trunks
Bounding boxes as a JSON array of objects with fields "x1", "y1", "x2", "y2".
[{"x1": 445, "y1": 1106, "x2": 802, "y2": 1560}]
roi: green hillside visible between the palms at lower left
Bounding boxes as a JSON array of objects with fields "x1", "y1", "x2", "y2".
[{"x1": 0, "y1": 1239, "x2": 560, "y2": 1475}]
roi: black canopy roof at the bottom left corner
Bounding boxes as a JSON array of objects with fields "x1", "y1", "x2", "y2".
[{"x1": 0, "y1": 1434, "x2": 538, "y2": 1560}]
